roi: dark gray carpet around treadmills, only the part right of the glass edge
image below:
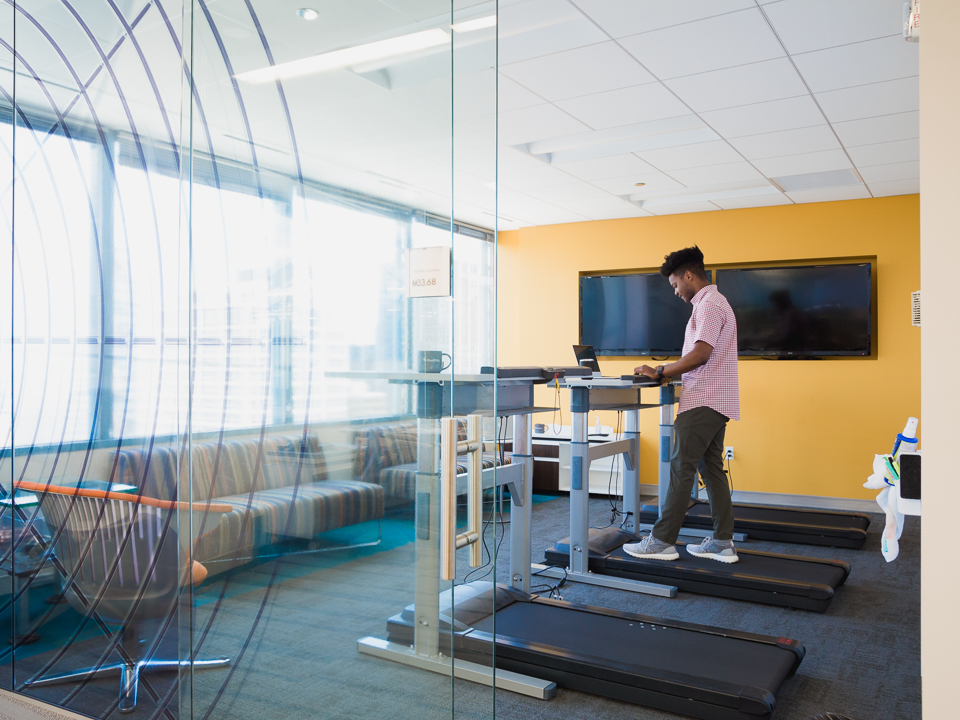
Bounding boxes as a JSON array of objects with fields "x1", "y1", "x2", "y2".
[{"x1": 484, "y1": 498, "x2": 921, "y2": 720}]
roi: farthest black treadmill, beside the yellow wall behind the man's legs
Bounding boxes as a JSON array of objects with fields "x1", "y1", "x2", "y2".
[{"x1": 638, "y1": 500, "x2": 870, "y2": 552}]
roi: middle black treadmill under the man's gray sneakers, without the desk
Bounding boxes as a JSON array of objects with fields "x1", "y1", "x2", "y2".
[{"x1": 544, "y1": 526, "x2": 850, "y2": 613}]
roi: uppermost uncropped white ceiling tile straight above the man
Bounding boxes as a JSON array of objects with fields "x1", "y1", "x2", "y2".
[{"x1": 620, "y1": 8, "x2": 785, "y2": 80}]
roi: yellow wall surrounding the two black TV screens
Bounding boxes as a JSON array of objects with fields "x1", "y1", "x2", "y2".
[{"x1": 498, "y1": 195, "x2": 922, "y2": 498}]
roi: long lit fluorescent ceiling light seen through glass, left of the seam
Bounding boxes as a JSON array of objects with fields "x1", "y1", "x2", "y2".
[{"x1": 236, "y1": 28, "x2": 450, "y2": 83}]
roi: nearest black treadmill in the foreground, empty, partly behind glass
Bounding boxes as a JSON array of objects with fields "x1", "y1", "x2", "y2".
[{"x1": 387, "y1": 581, "x2": 804, "y2": 720}]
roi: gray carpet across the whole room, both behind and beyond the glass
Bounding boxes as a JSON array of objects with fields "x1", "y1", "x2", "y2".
[{"x1": 11, "y1": 498, "x2": 920, "y2": 720}]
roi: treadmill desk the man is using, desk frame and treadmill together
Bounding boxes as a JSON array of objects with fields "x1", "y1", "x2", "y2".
[{"x1": 534, "y1": 378, "x2": 850, "y2": 612}]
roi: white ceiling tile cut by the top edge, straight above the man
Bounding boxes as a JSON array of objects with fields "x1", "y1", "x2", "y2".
[{"x1": 573, "y1": 0, "x2": 754, "y2": 38}]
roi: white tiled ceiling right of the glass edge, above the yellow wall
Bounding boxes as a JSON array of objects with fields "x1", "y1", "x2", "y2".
[{"x1": 488, "y1": 0, "x2": 920, "y2": 225}]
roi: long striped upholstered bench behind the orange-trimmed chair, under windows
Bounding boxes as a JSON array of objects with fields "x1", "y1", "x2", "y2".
[{"x1": 116, "y1": 435, "x2": 383, "y2": 563}]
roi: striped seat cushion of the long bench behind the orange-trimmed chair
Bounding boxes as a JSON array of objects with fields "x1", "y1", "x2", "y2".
[{"x1": 195, "y1": 480, "x2": 383, "y2": 563}]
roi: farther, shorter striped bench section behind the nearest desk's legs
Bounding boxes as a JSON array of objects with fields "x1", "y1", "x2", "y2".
[{"x1": 353, "y1": 419, "x2": 510, "y2": 507}]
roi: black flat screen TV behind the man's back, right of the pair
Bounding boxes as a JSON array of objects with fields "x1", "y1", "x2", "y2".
[{"x1": 717, "y1": 263, "x2": 873, "y2": 357}]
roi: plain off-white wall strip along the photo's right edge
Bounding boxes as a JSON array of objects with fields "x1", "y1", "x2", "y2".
[{"x1": 920, "y1": 0, "x2": 960, "y2": 720}]
